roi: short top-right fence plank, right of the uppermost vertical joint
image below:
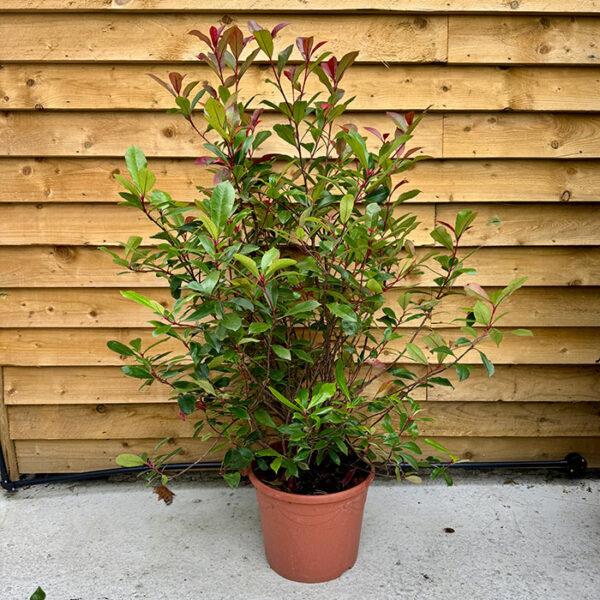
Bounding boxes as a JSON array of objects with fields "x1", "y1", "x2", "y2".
[{"x1": 448, "y1": 16, "x2": 600, "y2": 64}]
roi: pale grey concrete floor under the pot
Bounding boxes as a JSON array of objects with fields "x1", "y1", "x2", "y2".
[{"x1": 0, "y1": 472, "x2": 600, "y2": 600}]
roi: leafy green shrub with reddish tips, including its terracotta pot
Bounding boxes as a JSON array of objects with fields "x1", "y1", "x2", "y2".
[{"x1": 103, "y1": 21, "x2": 528, "y2": 581}]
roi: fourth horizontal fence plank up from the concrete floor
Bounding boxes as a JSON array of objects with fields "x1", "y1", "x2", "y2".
[{"x1": 0, "y1": 327, "x2": 600, "y2": 367}]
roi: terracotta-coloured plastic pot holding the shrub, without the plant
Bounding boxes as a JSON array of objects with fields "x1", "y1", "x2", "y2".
[{"x1": 249, "y1": 469, "x2": 374, "y2": 583}]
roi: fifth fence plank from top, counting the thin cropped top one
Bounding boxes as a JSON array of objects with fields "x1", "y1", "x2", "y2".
[{"x1": 0, "y1": 157, "x2": 600, "y2": 203}]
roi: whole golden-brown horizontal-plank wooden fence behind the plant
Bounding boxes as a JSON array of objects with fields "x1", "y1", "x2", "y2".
[{"x1": 0, "y1": 0, "x2": 600, "y2": 477}]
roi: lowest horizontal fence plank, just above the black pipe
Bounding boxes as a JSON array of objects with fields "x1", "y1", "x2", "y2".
[{"x1": 15, "y1": 436, "x2": 600, "y2": 474}]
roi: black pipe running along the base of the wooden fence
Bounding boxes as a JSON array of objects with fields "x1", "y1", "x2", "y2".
[{"x1": 0, "y1": 436, "x2": 587, "y2": 492}]
